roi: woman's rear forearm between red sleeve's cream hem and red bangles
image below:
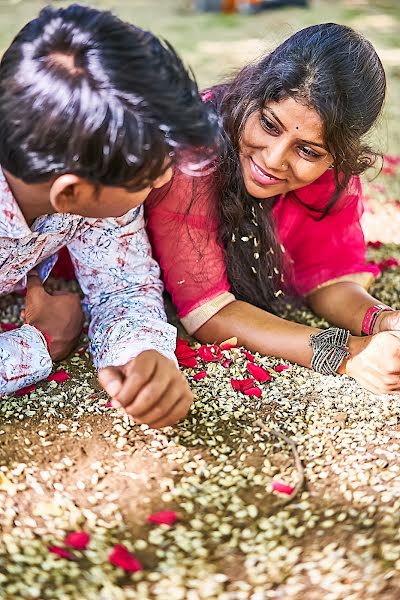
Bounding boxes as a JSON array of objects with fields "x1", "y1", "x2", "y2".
[{"x1": 308, "y1": 281, "x2": 388, "y2": 335}]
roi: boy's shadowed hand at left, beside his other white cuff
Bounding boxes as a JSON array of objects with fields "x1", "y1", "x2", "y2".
[{"x1": 24, "y1": 272, "x2": 83, "y2": 361}]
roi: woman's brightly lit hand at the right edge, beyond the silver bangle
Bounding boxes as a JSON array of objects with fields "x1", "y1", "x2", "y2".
[{"x1": 341, "y1": 331, "x2": 400, "y2": 394}]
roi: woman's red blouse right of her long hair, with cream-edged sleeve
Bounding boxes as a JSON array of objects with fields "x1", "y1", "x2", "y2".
[{"x1": 273, "y1": 171, "x2": 379, "y2": 295}]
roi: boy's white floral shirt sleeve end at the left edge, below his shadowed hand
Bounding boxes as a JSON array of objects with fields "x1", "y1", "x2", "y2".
[{"x1": 0, "y1": 325, "x2": 52, "y2": 394}]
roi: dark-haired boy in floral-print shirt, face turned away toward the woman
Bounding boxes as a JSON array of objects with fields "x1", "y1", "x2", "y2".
[{"x1": 0, "y1": 5, "x2": 218, "y2": 427}]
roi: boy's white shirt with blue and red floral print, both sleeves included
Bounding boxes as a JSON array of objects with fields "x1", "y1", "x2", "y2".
[{"x1": 0, "y1": 169, "x2": 176, "y2": 394}]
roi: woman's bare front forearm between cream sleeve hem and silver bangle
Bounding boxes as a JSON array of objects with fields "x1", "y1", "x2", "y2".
[{"x1": 194, "y1": 300, "x2": 320, "y2": 367}]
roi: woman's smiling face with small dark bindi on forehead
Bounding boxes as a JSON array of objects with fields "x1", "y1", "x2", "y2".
[{"x1": 239, "y1": 98, "x2": 333, "y2": 199}]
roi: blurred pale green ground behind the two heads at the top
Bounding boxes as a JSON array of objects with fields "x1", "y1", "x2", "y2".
[{"x1": 0, "y1": 0, "x2": 400, "y2": 154}]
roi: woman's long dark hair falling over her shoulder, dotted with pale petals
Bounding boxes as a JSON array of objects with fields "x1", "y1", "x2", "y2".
[{"x1": 206, "y1": 23, "x2": 386, "y2": 311}]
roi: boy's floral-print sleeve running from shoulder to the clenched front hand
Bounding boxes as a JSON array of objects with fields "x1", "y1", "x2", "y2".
[{"x1": 68, "y1": 206, "x2": 176, "y2": 368}]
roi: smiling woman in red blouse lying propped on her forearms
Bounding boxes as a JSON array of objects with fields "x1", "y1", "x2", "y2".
[{"x1": 148, "y1": 23, "x2": 400, "y2": 393}]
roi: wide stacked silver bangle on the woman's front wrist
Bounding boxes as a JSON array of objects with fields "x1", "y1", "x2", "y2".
[{"x1": 310, "y1": 327, "x2": 350, "y2": 375}]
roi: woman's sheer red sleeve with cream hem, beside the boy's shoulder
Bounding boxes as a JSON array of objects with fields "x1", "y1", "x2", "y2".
[{"x1": 145, "y1": 171, "x2": 235, "y2": 333}]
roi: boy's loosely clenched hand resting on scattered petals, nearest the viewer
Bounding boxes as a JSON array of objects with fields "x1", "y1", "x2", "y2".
[{"x1": 99, "y1": 350, "x2": 193, "y2": 429}]
